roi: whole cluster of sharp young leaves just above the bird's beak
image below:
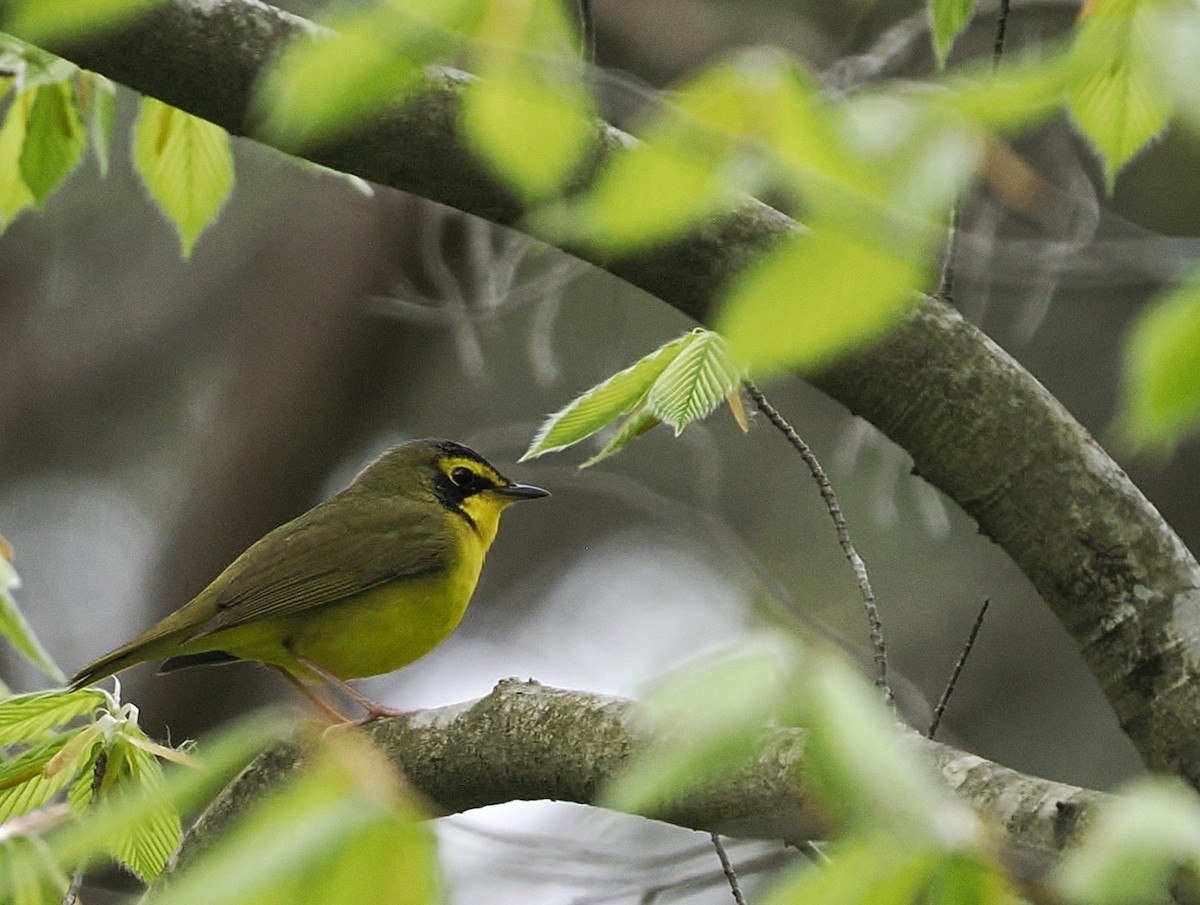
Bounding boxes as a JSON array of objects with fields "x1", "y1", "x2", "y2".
[{"x1": 521, "y1": 328, "x2": 746, "y2": 468}]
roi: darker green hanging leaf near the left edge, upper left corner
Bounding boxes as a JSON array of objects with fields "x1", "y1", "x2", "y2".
[{"x1": 20, "y1": 82, "x2": 86, "y2": 206}]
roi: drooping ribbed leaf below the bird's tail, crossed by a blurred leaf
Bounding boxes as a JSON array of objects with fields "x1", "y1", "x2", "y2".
[{"x1": 109, "y1": 726, "x2": 181, "y2": 882}]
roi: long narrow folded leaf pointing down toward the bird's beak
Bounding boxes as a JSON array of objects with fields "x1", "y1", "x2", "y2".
[{"x1": 521, "y1": 332, "x2": 695, "y2": 462}]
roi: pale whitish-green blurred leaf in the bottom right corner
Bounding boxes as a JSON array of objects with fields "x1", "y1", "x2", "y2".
[{"x1": 1055, "y1": 778, "x2": 1200, "y2": 905}]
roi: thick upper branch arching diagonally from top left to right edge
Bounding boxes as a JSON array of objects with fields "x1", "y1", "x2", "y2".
[{"x1": 7, "y1": 0, "x2": 1200, "y2": 786}]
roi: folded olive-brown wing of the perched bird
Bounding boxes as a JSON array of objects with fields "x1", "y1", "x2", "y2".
[{"x1": 192, "y1": 501, "x2": 454, "y2": 637}]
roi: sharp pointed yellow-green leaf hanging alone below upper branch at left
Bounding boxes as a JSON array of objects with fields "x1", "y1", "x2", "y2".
[{"x1": 133, "y1": 97, "x2": 233, "y2": 258}]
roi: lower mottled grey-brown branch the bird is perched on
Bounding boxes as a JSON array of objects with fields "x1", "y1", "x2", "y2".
[{"x1": 180, "y1": 679, "x2": 1106, "y2": 871}]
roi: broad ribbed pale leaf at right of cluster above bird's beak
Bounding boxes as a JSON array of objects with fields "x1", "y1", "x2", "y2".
[{"x1": 646, "y1": 330, "x2": 743, "y2": 437}]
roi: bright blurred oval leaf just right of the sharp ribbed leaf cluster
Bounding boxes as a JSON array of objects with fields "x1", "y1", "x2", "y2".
[{"x1": 718, "y1": 223, "x2": 926, "y2": 374}]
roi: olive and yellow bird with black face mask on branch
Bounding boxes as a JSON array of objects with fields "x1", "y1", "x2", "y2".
[{"x1": 71, "y1": 439, "x2": 548, "y2": 721}]
